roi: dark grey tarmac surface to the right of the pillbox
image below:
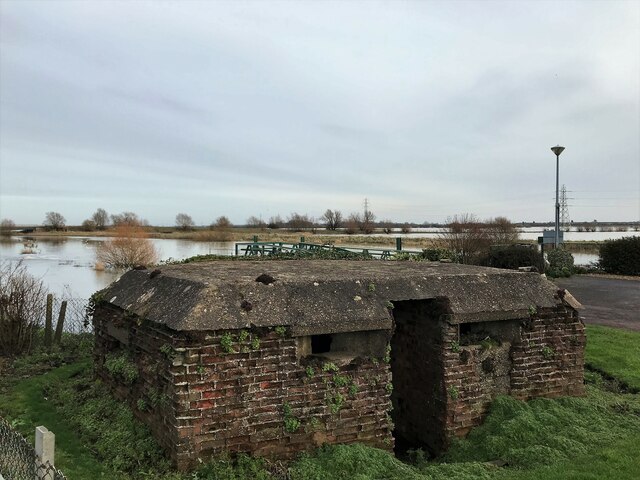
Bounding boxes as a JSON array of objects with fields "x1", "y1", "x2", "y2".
[{"x1": 554, "y1": 275, "x2": 640, "y2": 331}]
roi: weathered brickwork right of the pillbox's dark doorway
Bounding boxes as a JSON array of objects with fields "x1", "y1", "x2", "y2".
[{"x1": 443, "y1": 306, "x2": 586, "y2": 446}]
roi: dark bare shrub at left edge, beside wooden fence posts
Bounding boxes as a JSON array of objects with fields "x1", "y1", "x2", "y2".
[{"x1": 0, "y1": 262, "x2": 47, "y2": 355}]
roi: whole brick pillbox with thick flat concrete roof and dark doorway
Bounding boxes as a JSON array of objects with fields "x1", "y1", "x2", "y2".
[{"x1": 94, "y1": 261, "x2": 585, "y2": 469}]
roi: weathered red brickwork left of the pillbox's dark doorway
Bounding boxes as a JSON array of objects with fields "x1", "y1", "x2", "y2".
[{"x1": 95, "y1": 308, "x2": 393, "y2": 468}]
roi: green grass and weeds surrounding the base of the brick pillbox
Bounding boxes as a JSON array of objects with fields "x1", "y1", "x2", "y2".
[{"x1": 0, "y1": 326, "x2": 640, "y2": 480}]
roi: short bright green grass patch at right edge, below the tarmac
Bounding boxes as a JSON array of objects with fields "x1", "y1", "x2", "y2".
[{"x1": 585, "y1": 325, "x2": 640, "y2": 391}]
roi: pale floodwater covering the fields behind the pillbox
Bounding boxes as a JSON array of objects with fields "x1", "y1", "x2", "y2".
[{"x1": 0, "y1": 227, "x2": 640, "y2": 299}]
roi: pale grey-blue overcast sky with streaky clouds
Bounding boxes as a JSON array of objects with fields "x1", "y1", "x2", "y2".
[{"x1": 0, "y1": 0, "x2": 640, "y2": 225}]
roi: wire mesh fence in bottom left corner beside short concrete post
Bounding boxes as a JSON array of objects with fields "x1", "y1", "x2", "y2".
[{"x1": 0, "y1": 417, "x2": 67, "y2": 480}]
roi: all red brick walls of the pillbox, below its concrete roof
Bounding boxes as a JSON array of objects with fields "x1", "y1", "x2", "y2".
[{"x1": 94, "y1": 302, "x2": 585, "y2": 468}]
